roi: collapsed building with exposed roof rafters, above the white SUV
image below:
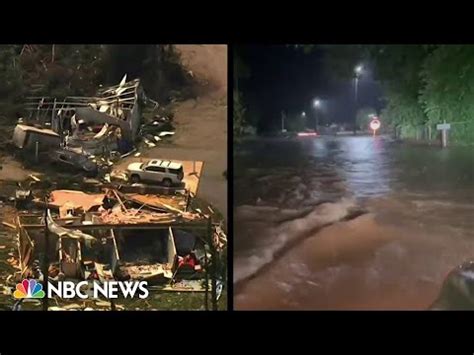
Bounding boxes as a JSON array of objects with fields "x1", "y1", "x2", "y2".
[{"x1": 13, "y1": 75, "x2": 149, "y2": 170}]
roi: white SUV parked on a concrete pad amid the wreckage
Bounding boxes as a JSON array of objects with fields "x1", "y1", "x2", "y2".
[{"x1": 127, "y1": 160, "x2": 184, "y2": 186}]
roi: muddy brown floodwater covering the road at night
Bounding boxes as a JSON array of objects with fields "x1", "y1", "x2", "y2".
[{"x1": 234, "y1": 136, "x2": 474, "y2": 309}]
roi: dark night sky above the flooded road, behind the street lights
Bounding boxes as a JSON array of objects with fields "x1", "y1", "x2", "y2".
[{"x1": 238, "y1": 45, "x2": 381, "y2": 132}]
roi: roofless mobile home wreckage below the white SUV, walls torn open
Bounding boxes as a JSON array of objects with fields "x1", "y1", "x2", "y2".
[{"x1": 12, "y1": 191, "x2": 227, "y2": 291}]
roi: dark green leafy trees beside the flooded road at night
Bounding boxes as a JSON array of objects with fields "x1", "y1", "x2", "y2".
[{"x1": 234, "y1": 44, "x2": 474, "y2": 144}]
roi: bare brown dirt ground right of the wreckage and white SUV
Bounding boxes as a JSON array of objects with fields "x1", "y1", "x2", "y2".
[{"x1": 155, "y1": 45, "x2": 228, "y2": 220}]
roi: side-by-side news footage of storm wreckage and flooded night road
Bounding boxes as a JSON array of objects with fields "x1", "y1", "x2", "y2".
[{"x1": 0, "y1": 43, "x2": 474, "y2": 311}]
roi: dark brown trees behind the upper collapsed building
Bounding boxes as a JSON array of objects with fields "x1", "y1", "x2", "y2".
[{"x1": 0, "y1": 44, "x2": 192, "y2": 124}]
